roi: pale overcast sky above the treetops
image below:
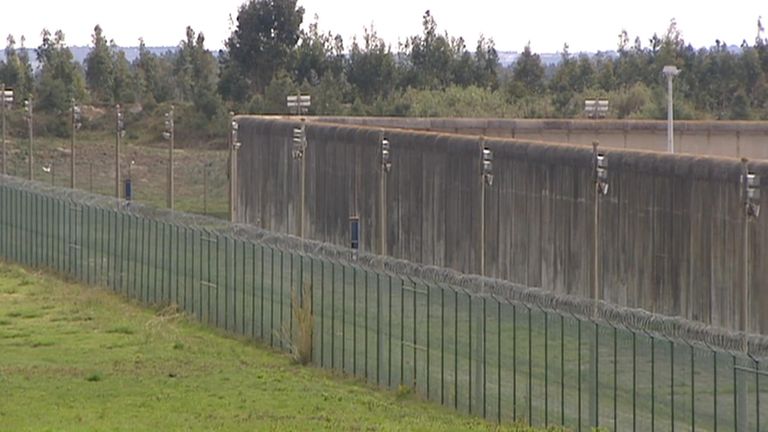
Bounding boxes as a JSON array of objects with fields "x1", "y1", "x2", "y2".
[{"x1": 0, "y1": 0, "x2": 768, "y2": 52}]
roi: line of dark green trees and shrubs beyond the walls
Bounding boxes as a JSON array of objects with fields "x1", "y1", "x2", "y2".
[{"x1": 0, "y1": 0, "x2": 768, "y2": 142}]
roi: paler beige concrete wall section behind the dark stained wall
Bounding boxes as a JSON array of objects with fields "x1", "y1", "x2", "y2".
[{"x1": 316, "y1": 117, "x2": 768, "y2": 159}]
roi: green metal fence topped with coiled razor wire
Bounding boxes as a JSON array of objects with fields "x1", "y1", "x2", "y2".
[{"x1": 0, "y1": 176, "x2": 768, "y2": 431}]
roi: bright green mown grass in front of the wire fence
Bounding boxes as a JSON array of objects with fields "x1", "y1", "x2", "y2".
[{"x1": 0, "y1": 264, "x2": 544, "y2": 431}]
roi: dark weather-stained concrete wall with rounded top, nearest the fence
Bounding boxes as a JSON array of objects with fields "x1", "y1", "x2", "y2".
[{"x1": 236, "y1": 117, "x2": 768, "y2": 333}]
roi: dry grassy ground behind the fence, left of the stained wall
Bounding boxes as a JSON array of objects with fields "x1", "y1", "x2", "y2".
[{"x1": 3, "y1": 132, "x2": 229, "y2": 218}]
